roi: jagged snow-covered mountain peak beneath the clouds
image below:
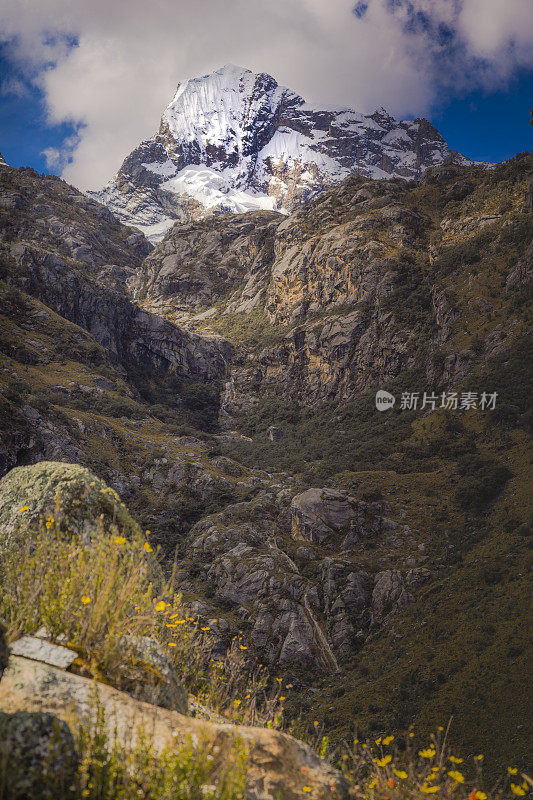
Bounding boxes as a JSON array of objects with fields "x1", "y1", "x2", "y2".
[{"x1": 92, "y1": 64, "x2": 470, "y2": 242}]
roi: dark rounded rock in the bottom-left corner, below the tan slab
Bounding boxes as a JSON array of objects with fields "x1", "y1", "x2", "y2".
[{"x1": 0, "y1": 710, "x2": 76, "y2": 800}]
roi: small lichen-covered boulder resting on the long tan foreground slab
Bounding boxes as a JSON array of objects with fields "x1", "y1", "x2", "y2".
[{"x1": 113, "y1": 636, "x2": 189, "y2": 714}]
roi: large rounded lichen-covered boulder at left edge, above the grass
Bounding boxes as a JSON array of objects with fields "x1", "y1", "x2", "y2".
[{"x1": 0, "y1": 461, "x2": 138, "y2": 548}]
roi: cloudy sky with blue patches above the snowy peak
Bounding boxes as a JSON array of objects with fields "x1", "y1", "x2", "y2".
[{"x1": 0, "y1": 0, "x2": 533, "y2": 188}]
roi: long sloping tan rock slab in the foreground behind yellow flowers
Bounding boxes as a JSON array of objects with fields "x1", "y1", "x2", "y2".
[{"x1": 0, "y1": 656, "x2": 349, "y2": 800}]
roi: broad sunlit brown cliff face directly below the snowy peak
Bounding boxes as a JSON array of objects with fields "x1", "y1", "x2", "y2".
[{"x1": 135, "y1": 157, "x2": 530, "y2": 410}]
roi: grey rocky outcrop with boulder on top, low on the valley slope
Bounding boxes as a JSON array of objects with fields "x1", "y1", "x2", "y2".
[{"x1": 177, "y1": 487, "x2": 412, "y2": 673}]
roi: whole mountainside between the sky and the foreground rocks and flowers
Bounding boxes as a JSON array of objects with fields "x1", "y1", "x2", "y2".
[{"x1": 0, "y1": 141, "x2": 533, "y2": 784}]
